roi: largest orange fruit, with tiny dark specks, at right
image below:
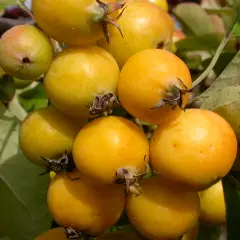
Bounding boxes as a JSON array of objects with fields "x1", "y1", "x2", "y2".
[{"x1": 150, "y1": 109, "x2": 237, "y2": 190}]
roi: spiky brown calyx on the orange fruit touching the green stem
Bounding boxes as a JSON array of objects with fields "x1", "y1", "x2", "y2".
[{"x1": 151, "y1": 78, "x2": 192, "y2": 110}]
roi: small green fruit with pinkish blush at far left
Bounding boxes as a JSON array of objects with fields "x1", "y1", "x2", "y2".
[{"x1": 0, "y1": 25, "x2": 53, "y2": 80}]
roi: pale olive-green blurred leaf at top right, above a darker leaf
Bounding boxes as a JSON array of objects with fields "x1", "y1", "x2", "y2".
[{"x1": 173, "y1": 3, "x2": 214, "y2": 36}]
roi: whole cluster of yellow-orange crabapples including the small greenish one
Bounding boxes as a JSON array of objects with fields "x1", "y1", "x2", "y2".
[{"x1": 0, "y1": 0, "x2": 237, "y2": 240}]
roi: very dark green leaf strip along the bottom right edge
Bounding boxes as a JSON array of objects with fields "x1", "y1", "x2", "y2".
[{"x1": 222, "y1": 175, "x2": 240, "y2": 240}]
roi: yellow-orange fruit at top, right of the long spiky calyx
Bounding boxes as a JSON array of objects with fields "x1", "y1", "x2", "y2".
[{"x1": 98, "y1": 1, "x2": 174, "y2": 68}]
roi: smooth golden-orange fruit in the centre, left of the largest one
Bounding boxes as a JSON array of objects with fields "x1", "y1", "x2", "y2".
[{"x1": 73, "y1": 116, "x2": 149, "y2": 184}]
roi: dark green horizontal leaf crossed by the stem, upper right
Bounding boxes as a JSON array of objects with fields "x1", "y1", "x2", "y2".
[{"x1": 175, "y1": 33, "x2": 236, "y2": 54}]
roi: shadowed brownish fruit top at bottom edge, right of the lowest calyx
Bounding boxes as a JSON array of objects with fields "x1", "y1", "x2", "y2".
[{"x1": 96, "y1": 231, "x2": 145, "y2": 240}]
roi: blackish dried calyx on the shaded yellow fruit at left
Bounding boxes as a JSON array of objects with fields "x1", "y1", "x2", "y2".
[{"x1": 40, "y1": 150, "x2": 75, "y2": 176}]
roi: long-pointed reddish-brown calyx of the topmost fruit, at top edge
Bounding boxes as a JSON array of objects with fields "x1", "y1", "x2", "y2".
[{"x1": 96, "y1": 0, "x2": 126, "y2": 43}]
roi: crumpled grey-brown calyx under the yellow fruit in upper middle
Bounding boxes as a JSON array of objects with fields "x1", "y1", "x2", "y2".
[{"x1": 89, "y1": 93, "x2": 119, "y2": 115}]
